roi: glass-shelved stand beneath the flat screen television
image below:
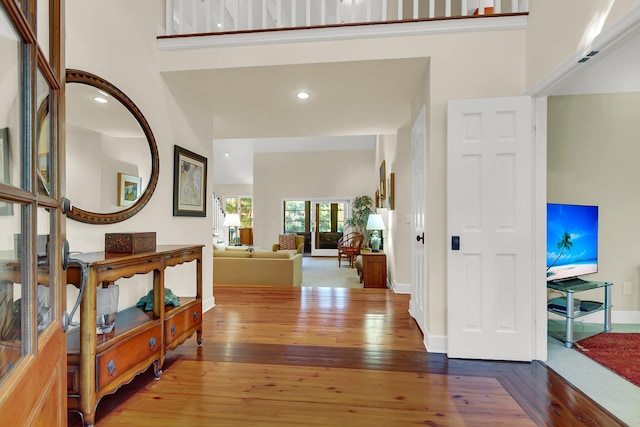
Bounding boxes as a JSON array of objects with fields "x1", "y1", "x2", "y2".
[{"x1": 547, "y1": 279, "x2": 613, "y2": 348}]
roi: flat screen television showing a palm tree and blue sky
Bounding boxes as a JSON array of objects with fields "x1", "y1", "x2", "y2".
[{"x1": 547, "y1": 203, "x2": 598, "y2": 282}]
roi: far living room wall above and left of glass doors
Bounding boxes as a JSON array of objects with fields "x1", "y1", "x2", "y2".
[{"x1": 253, "y1": 150, "x2": 378, "y2": 248}]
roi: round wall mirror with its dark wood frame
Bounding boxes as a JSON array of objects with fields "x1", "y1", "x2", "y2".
[{"x1": 65, "y1": 69, "x2": 159, "y2": 224}]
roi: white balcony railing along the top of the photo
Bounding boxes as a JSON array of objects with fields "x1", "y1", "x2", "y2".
[{"x1": 166, "y1": 0, "x2": 528, "y2": 36}]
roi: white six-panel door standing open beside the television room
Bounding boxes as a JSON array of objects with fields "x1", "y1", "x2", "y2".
[{"x1": 447, "y1": 97, "x2": 544, "y2": 360}]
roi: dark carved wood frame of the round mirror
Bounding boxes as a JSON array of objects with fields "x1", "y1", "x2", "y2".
[{"x1": 66, "y1": 69, "x2": 160, "y2": 224}]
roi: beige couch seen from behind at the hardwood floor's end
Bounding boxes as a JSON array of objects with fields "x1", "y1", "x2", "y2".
[{"x1": 213, "y1": 245, "x2": 302, "y2": 286}]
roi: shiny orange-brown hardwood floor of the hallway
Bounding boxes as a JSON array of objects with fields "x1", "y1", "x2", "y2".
[{"x1": 69, "y1": 286, "x2": 624, "y2": 427}]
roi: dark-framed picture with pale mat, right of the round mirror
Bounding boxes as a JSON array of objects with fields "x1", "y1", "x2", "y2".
[{"x1": 173, "y1": 145, "x2": 207, "y2": 216}]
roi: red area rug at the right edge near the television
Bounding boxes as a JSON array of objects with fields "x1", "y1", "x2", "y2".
[{"x1": 574, "y1": 332, "x2": 640, "y2": 387}]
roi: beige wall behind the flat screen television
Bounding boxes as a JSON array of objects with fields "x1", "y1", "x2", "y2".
[{"x1": 547, "y1": 92, "x2": 640, "y2": 311}]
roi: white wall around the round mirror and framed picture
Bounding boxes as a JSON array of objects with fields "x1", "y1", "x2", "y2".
[{"x1": 64, "y1": 0, "x2": 213, "y2": 308}]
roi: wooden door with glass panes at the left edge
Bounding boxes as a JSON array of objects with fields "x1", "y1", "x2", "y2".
[{"x1": 0, "y1": 0, "x2": 67, "y2": 426}]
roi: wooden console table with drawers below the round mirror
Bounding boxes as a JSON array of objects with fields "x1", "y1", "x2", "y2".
[{"x1": 67, "y1": 245, "x2": 202, "y2": 426}]
